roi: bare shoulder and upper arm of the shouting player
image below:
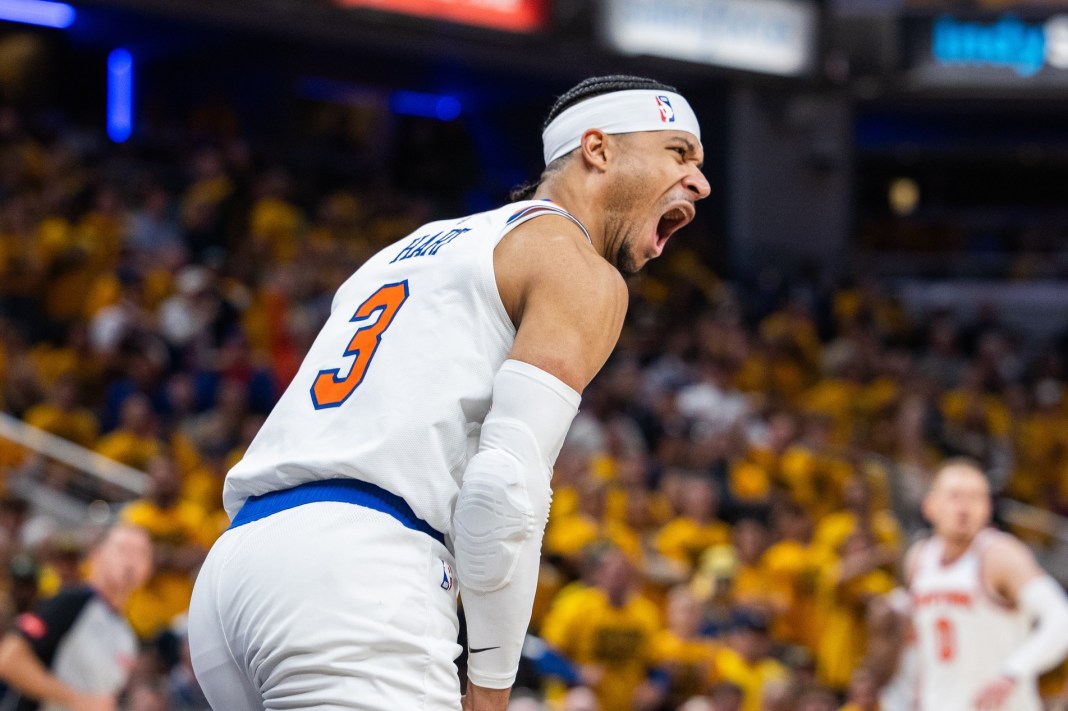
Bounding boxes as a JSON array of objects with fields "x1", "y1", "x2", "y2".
[{"x1": 493, "y1": 215, "x2": 628, "y2": 392}]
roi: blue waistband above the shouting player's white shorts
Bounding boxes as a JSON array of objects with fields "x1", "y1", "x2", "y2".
[{"x1": 230, "y1": 479, "x2": 445, "y2": 546}]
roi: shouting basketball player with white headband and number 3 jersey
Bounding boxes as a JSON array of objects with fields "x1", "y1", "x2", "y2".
[{"x1": 189, "y1": 77, "x2": 709, "y2": 711}]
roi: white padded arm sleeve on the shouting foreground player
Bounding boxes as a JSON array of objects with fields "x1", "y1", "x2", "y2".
[{"x1": 453, "y1": 360, "x2": 580, "y2": 689}]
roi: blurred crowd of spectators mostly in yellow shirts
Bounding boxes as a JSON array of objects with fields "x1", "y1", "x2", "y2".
[{"x1": 0, "y1": 105, "x2": 1068, "y2": 711}]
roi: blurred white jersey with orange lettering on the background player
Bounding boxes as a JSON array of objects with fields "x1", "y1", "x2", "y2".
[{"x1": 909, "y1": 528, "x2": 1042, "y2": 711}]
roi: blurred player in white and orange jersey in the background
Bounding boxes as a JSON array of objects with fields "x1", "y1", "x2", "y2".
[{"x1": 906, "y1": 459, "x2": 1068, "y2": 711}]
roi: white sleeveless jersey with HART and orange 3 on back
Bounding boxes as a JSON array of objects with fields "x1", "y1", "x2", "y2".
[{"x1": 223, "y1": 201, "x2": 588, "y2": 533}]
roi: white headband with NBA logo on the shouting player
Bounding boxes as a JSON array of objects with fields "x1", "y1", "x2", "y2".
[{"x1": 541, "y1": 89, "x2": 701, "y2": 165}]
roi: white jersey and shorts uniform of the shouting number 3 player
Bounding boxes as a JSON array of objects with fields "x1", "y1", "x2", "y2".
[{"x1": 189, "y1": 201, "x2": 581, "y2": 711}]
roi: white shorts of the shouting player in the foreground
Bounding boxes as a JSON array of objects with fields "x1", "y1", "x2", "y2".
[{"x1": 189, "y1": 502, "x2": 460, "y2": 711}]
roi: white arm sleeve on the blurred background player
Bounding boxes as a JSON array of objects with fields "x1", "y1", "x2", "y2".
[{"x1": 1004, "y1": 575, "x2": 1068, "y2": 679}]
